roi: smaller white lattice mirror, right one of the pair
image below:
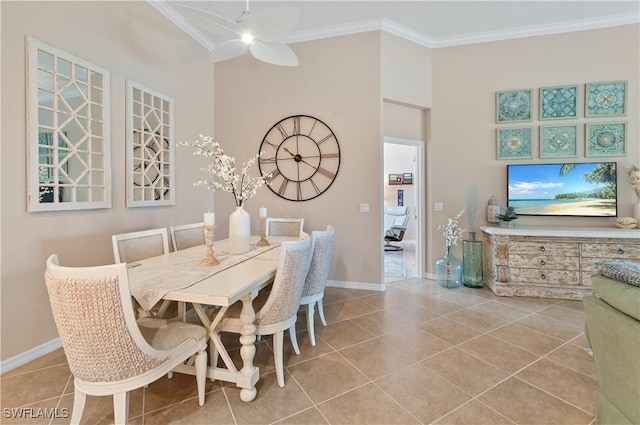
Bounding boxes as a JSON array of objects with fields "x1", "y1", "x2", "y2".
[{"x1": 127, "y1": 80, "x2": 175, "y2": 207}]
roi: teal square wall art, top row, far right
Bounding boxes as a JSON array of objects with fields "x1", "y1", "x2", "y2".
[{"x1": 584, "y1": 81, "x2": 627, "y2": 117}]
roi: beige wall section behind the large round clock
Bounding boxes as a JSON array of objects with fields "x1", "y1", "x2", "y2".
[{"x1": 215, "y1": 32, "x2": 382, "y2": 284}]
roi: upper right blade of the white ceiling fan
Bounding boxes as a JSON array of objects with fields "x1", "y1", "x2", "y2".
[{"x1": 238, "y1": 7, "x2": 300, "y2": 43}]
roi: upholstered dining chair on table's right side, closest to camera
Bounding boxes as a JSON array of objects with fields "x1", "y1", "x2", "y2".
[{"x1": 212, "y1": 239, "x2": 313, "y2": 387}]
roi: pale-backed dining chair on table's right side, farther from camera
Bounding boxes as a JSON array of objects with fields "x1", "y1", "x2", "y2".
[{"x1": 300, "y1": 226, "x2": 336, "y2": 345}]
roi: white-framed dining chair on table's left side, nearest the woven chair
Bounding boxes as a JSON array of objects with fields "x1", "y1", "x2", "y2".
[{"x1": 111, "y1": 227, "x2": 176, "y2": 319}]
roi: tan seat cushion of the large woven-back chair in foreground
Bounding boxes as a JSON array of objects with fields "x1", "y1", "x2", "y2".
[{"x1": 137, "y1": 317, "x2": 207, "y2": 351}]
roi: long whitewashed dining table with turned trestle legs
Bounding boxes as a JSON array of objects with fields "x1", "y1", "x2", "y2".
[{"x1": 127, "y1": 236, "x2": 298, "y2": 402}]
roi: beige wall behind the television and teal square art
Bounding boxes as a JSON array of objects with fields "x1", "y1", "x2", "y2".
[{"x1": 427, "y1": 25, "x2": 640, "y2": 264}]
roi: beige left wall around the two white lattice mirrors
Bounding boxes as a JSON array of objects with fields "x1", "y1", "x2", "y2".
[{"x1": 0, "y1": 1, "x2": 213, "y2": 360}]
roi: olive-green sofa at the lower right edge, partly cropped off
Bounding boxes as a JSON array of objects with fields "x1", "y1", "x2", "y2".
[{"x1": 583, "y1": 274, "x2": 640, "y2": 425}]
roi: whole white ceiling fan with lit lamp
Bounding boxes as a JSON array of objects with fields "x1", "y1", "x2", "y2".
[{"x1": 175, "y1": 0, "x2": 299, "y2": 66}]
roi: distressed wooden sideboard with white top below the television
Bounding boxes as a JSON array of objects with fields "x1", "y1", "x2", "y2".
[{"x1": 480, "y1": 226, "x2": 640, "y2": 300}]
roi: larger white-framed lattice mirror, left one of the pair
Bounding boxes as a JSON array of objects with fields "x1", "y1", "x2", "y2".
[{"x1": 27, "y1": 37, "x2": 111, "y2": 212}]
